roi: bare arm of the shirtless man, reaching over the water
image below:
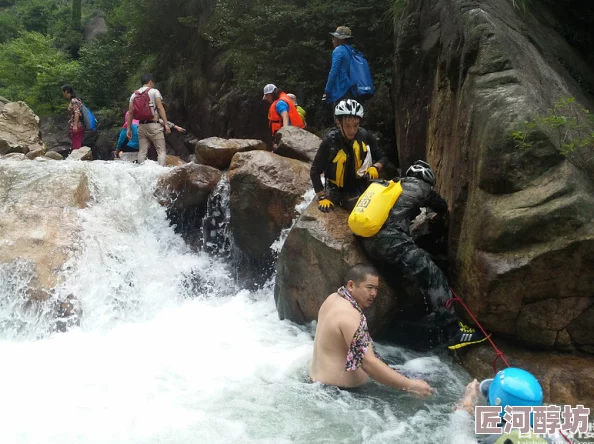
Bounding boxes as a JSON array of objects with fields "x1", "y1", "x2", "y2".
[{"x1": 339, "y1": 310, "x2": 433, "y2": 398}]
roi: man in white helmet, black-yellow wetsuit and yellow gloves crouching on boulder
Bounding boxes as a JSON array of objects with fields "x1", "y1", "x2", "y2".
[{"x1": 310, "y1": 99, "x2": 388, "y2": 212}]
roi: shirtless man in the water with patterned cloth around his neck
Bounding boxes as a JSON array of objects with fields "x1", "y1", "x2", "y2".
[{"x1": 310, "y1": 264, "x2": 433, "y2": 397}]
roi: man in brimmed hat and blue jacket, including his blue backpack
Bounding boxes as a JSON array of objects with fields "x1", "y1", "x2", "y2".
[{"x1": 322, "y1": 26, "x2": 375, "y2": 108}]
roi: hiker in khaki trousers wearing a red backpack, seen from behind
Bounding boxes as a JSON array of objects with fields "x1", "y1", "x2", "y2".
[{"x1": 126, "y1": 74, "x2": 171, "y2": 166}]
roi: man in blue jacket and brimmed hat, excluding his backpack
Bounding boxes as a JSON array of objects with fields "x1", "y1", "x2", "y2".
[{"x1": 322, "y1": 26, "x2": 353, "y2": 105}]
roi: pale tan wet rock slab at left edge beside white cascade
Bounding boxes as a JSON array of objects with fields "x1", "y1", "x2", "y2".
[{"x1": 0, "y1": 163, "x2": 90, "y2": 300}]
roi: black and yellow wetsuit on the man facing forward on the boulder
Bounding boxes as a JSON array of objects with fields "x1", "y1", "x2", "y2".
[{"x1": 310, "y1": 128, "x2": 388, "y2": 210}]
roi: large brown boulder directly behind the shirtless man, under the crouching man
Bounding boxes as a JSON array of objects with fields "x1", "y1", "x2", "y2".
[{"x1": 274, "y1": 200, "x2": 397, "y2": 337}]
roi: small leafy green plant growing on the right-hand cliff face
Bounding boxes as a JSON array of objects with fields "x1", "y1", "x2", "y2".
[{"x1": 512, "y1": 97, "x2": 594, "y2": 172}]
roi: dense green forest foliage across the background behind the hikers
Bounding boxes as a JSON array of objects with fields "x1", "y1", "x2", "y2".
[{"x1": 0, "y1": 0, "x2": 402, "y2": 138}]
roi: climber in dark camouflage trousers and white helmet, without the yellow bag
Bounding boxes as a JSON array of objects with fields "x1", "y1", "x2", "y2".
[{"x1": 360, "y1": 160, "x2": 487, "y2": 350}]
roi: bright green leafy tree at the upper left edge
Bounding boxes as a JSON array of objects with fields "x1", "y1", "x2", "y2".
[{"x1": 0, "y1": 32, "x2": 79, "y2": 115}]
